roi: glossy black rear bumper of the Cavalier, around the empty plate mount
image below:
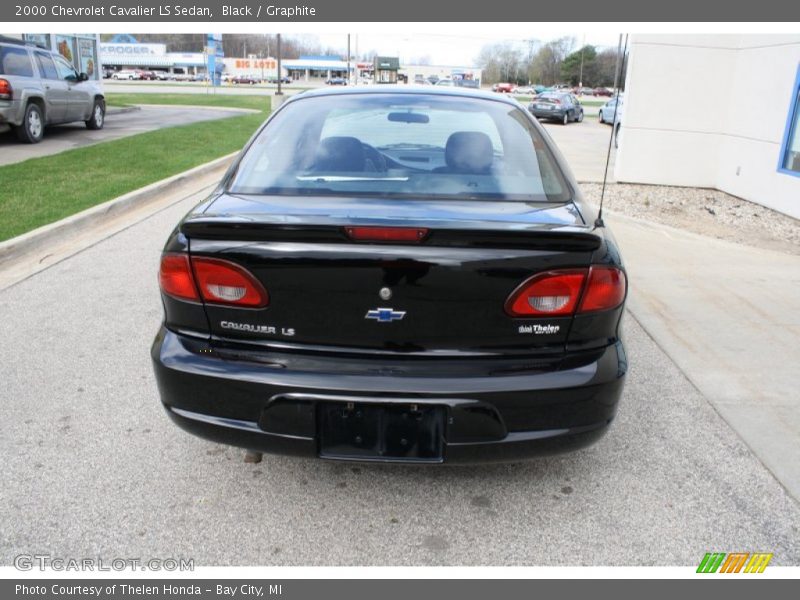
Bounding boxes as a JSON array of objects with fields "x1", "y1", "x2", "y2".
[{"x1": 152, "y1": 328, "x2": 627, "y2": 464}]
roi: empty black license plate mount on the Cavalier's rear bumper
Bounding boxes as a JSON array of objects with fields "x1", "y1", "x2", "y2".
[{"x1": 317, "y1": 402, "x2": 446, "y2": 462}]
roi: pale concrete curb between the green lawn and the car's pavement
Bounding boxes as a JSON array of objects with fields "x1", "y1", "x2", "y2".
[{"x1": 0, "y1": 151, "x2": 238, "y2": 262}]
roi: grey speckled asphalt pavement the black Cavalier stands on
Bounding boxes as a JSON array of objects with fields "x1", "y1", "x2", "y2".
[{"x1": 0, "y1": 189, "x2": 800, "y2": 565}]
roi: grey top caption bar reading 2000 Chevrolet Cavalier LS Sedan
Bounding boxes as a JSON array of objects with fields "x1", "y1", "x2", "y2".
[{"x1": 0, "y1": 0, "x2": 800, "y2": 23}]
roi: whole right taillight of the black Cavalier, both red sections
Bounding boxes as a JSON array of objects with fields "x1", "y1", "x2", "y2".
[{"x1": 505, "y1": 266, "x2": 626, "y2": 318}]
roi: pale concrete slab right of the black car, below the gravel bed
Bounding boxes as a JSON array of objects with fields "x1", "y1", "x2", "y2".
[{"x1": 606, "y1": 213, "x2": 800, "y2": 500}]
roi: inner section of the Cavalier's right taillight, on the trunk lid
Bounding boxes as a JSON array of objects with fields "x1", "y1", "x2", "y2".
[{"x1": 506, "y1": 269, "x2": 586, "y2": 317}]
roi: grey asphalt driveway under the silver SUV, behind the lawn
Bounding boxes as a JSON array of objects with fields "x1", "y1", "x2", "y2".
[{"x1": 0, "y1": 106, "x2": 249, "y2": 165}]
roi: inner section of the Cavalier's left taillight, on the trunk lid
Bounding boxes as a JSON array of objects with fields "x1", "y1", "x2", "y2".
[{"x1": 192, "y1": 257, "x2": 269, "y2": 308}]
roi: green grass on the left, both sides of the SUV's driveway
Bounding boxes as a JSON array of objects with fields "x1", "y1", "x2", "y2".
[{"x1": 0, "y1": 94, "x2": 269, "y2": 241}]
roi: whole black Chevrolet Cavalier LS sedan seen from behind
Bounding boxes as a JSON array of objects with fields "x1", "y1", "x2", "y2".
[{"x1": 152, "y1": 86, "x2": 627, "y2": 463}]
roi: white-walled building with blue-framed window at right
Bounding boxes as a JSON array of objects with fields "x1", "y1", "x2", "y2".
[{"x1": 615, "y1": 34, "x2": 800, "y2": 218}]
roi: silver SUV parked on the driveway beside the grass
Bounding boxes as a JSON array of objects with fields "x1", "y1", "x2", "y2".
[{"x1": 0, "y1": 38, "x2": 106, "y2": 144}]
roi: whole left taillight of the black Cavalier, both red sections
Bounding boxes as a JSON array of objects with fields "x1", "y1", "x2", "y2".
[{"x1": 158, "y1": 254, "x2": 269, "y2": 308}]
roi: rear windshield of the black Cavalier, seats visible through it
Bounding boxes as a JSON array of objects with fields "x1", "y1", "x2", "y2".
[{"x1": 228, "y1": 94, "x2": 571, "y2": 202}]
